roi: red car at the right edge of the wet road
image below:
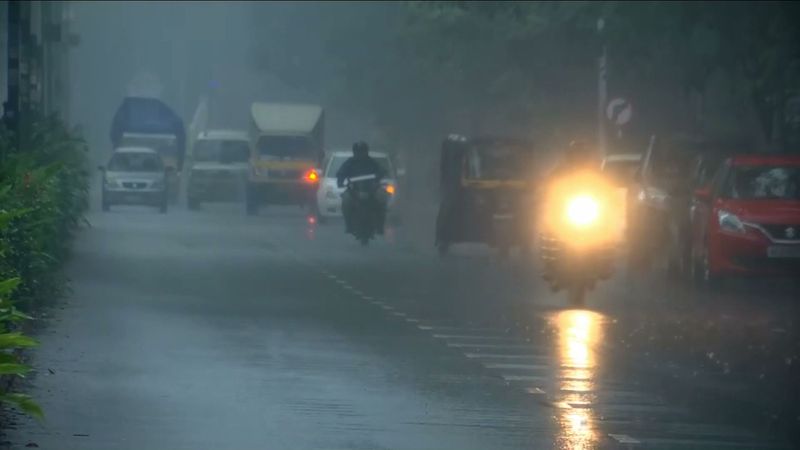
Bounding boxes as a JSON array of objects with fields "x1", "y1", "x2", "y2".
[{"x1": 690, "y1": 154, "x2": 800, "y2": 284}]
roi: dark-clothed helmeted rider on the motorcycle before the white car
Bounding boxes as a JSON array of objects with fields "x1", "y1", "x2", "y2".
[{"x1": 336, "y1": 141, "x2": 386, "y2": 235}]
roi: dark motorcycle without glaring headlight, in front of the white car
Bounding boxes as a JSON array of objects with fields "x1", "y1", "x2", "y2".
[{"x1": 345, "y1": 175, "x2": 384, "y2": 246}]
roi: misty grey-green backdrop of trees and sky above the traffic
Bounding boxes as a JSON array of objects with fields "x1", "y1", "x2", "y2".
[{"x1": 71, "y1": 2, "x2": 800, "y2": 187}]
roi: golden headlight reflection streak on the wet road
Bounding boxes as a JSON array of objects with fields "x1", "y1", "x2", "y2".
[{"x1": 552, "y1": 310, "x2": 603, "y2": 450}]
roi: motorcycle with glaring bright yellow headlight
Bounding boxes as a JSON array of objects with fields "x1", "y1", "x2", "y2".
[{"x1": 539, "y1": 173, "x2": 623, "y2": 307}]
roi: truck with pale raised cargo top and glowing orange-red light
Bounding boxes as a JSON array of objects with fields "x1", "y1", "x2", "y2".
[{"x1": 245, "y1": 102, "x2": 325, "y2": 215}]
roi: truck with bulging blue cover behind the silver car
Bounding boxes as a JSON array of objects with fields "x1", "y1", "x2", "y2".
[{"x1": 110, "y1": 97, "x2": 186, "y2": 202}]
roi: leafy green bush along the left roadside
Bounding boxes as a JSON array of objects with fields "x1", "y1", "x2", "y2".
[{"x1": 0, "y1": 114, "x2": 89, "y2": 422}]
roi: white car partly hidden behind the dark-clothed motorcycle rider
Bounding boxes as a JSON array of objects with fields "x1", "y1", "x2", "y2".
[{"x1": 317, "y1": 150, "x2": 397, "y2": 222}]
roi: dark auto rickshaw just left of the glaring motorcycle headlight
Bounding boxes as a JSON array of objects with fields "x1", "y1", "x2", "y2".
[{"x1": 436, "y1": 135, "x2": 534, "y2": 257}]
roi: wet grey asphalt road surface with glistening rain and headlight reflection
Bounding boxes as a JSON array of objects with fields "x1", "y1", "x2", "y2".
[{"x1": 4, "y1": 201, "x2": 800, "y2": 450}]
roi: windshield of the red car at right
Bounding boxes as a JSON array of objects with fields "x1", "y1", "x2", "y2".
[{"x1": 723, "y1": 166, "x2": 800, "y2": 200}]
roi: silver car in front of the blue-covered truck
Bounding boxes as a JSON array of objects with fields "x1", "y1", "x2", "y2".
[{"x1": 98, "y1": 147, "x2": 174, "y2": 213}]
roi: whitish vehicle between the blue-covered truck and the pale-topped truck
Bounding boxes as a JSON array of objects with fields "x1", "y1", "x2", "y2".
[{"x1": 186, "y1": 130, "x2": 250, "y2": 209}]
